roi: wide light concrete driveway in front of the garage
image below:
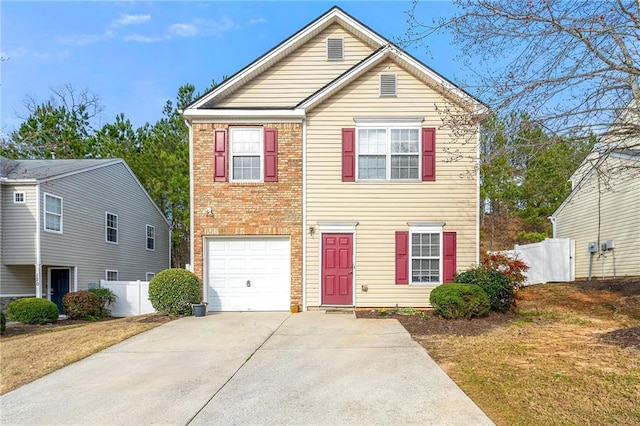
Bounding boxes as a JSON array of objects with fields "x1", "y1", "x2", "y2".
[{"x1": 0, "y1": 312, "x2": 492, "y2": 425}]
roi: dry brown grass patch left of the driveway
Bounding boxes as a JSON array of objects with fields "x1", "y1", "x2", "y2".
[{"x1": 0, "y1": 314, "x2": 170, "y2": 395}]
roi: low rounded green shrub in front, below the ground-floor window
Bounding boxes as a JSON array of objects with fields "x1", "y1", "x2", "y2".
[{"x1": 429, "y1": 284, "x2": 491, "y2": 319}]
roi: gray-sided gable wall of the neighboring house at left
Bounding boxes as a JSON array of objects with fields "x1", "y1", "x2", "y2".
[{"x1": 40, "y1": 163, "x2": 169, "y2": 289}]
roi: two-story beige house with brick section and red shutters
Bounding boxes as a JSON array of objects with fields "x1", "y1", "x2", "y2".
[{"x1": 183, "y1": 7, "x2": 486, "y2": 311}]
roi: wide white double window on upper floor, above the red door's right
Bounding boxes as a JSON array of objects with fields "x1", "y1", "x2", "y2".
[{"x1": 357, "y1": 127, "x2": 420, "y2": 180}]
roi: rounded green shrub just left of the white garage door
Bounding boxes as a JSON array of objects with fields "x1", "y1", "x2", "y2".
[{"x1": 149, "y1": 268, "x2": 200, "y2": 316}]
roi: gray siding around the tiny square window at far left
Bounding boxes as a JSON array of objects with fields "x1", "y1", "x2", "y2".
[{"x1": 2, "y1": 185, "x2": 36, "y2": 265}]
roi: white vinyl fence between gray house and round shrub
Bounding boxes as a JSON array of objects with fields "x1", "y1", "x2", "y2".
[{"x1": 100, "y1": 280, "x2": 156, "y2": 317}]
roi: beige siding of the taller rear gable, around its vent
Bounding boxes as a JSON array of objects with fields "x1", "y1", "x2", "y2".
[{"x1": 216, "y1": 24, "x2": 374, "y2": 107}]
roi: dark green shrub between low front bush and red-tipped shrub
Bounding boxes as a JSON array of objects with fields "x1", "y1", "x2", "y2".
[{"x1": 453, "y1": 266, "x2": 515, "y2": 312}]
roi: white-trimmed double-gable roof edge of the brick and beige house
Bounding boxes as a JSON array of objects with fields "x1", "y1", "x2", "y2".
[{"x1": 182, "y1": 6, "x2": 488, "y2": 118}]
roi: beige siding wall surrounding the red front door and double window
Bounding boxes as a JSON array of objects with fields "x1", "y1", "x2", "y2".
[{"x1": 306, "y1": 61, "x2": 478, "y2": 307}]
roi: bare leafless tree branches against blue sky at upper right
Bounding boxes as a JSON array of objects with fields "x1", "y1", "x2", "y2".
[{"x1": 405, "y1": 0, "x2": 640, "y2": 156}]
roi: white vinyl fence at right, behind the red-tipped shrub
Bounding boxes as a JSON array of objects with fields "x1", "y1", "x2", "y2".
[{"x1": 502, "y1": 238, "x2": 576, "y2": 285}]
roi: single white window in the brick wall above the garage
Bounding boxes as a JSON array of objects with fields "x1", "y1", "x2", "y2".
[{"x1": 229, "y1": 127, "x2": 263, "y2": 181}]
